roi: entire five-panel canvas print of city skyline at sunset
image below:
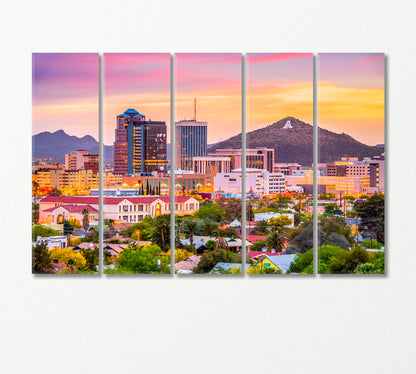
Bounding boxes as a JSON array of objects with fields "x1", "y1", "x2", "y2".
[{"x1": 31, "y1": 53, "x2": 385, "y2": 275}]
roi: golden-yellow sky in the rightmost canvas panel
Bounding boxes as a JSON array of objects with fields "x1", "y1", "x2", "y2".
[{"x1": 318, "y1": 53, "x2": 384, "y2": 145}]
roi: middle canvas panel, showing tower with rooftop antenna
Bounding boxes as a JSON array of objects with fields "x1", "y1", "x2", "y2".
[{"x1": 174, "y1": 53, "x2": 244, "y2": 274}]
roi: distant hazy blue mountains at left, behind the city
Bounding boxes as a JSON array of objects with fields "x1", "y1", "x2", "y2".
[{"x1": 32, "y1": 130, "x2": 114, "y2": 162}]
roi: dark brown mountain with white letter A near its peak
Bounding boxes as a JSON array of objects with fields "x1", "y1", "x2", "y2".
[{"x1": 208, "y1": 117, "x2": 384, "y2": 166}]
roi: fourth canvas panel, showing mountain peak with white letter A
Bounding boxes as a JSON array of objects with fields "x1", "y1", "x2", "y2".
[{"x1": 246, "y1": 53, "x2": 313, "y2": 274}]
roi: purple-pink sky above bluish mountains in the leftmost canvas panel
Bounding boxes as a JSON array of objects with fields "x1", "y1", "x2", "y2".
[{"x1": 32, "y1": 53, "x2": 99, "y2": 140}]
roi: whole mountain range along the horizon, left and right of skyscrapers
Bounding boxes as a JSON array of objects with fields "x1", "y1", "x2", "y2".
[{"x1": 32, "y1": 117, "x2": 384, "y2": 166}]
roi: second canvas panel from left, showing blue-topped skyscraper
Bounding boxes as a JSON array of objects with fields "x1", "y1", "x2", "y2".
[{"x1": 102, "y1": 53, "x2": 172, "y2": 274}]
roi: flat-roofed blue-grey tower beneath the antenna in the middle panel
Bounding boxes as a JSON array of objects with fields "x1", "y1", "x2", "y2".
[{"x1": 175, "y1": 119, "x2": 208, "y2": 170}]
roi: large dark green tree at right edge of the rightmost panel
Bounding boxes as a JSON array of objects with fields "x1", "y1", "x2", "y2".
[{"x1": 354, "y1": 194, "x2": 384, "y2": 243}]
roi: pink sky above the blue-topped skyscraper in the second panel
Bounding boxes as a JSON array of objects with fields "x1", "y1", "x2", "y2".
[{"x1": 103, "y1": 53, "x2": 170, "y2": 145}]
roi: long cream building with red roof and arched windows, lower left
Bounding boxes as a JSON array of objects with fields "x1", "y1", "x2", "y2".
[{"x1": 39, "y1": 196, "x2": 199, "y2": 223}]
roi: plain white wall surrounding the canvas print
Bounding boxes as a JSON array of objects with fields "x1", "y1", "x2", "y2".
[{"x1": 0, "y1": 0, "x2": 416, "y2": 374}]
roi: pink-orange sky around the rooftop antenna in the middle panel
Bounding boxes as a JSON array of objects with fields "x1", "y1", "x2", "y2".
[{"x1": 175, "y1": 53, "x2": 242, "y2": 144}]
